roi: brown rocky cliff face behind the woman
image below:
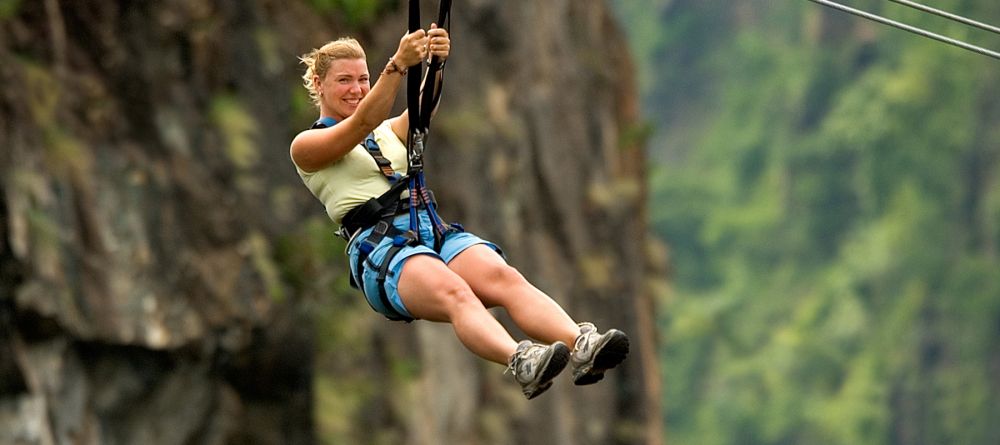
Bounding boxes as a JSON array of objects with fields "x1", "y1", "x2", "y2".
[{"x1": 0, "y1": 0, "x2": 660, "y2": 444}]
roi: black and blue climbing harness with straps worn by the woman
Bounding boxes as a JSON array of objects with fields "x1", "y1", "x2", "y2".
[{"x1": 311, "y1": 0, "x2": 464, "y2": 322}]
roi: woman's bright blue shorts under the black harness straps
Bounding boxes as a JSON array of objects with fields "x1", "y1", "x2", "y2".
[{"x1": 347, "y1": 210, "x2": 500, "y2": 318}]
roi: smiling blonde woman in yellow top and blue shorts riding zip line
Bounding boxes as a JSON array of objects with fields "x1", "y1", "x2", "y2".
[{"x1": 291, "y1": 24, "x2": 628, "y2": 399}]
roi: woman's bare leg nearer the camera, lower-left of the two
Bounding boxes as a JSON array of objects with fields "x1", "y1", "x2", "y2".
[{"x1": 397, "y1": 255, "x2": 517, "y2": 365}]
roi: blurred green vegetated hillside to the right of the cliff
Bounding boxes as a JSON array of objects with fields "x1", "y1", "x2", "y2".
[{"x1": 614, "y1": 0, "x2": 1000, "y2": 445}]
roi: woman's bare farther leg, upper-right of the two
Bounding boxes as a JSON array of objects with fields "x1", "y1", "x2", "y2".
[{"x1": 446, "y1": 244, "x2": 580, "y2": 347}]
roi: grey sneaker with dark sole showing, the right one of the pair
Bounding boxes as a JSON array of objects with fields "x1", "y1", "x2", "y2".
[{"x1": 569, "y1": 322, "x2": 628, "y2": 385}]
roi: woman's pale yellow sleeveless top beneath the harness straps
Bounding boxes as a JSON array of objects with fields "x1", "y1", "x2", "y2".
[{"x1": 292, "y1": 120, "x2": 406, "y2": 225}]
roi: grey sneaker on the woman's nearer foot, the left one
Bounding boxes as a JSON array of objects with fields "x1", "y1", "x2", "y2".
[{"x1": 504, "y1": 340, "x2": 569, "y2": 400}]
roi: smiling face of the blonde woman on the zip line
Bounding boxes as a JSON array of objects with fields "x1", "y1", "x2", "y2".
[{"x1": 318, "y1": 59, "x2": 371, "y2": 120}]
